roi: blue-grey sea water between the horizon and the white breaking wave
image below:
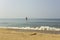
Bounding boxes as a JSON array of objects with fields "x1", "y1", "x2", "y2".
[{"x1": 0, "y1": 18, "x2": 60, "y2": 28}]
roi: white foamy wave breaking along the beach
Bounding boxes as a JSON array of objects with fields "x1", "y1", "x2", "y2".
[{"x1": 0, "y1": 26, "x2": 60, "y2": 31}]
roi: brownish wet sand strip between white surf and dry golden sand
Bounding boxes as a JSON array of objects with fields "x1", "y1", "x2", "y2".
[{"x1": 0, "y1": 28, "x2": 60, "y2": 34}]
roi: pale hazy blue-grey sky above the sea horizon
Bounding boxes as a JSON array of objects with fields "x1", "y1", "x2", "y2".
[{"x1": 0, "y1": 0, "x2": 60, "y2": 18}]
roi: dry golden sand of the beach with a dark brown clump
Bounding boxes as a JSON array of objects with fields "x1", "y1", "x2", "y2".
[{"x1": 0, "y1": 28, "x2": 60, "y2": 40}]
